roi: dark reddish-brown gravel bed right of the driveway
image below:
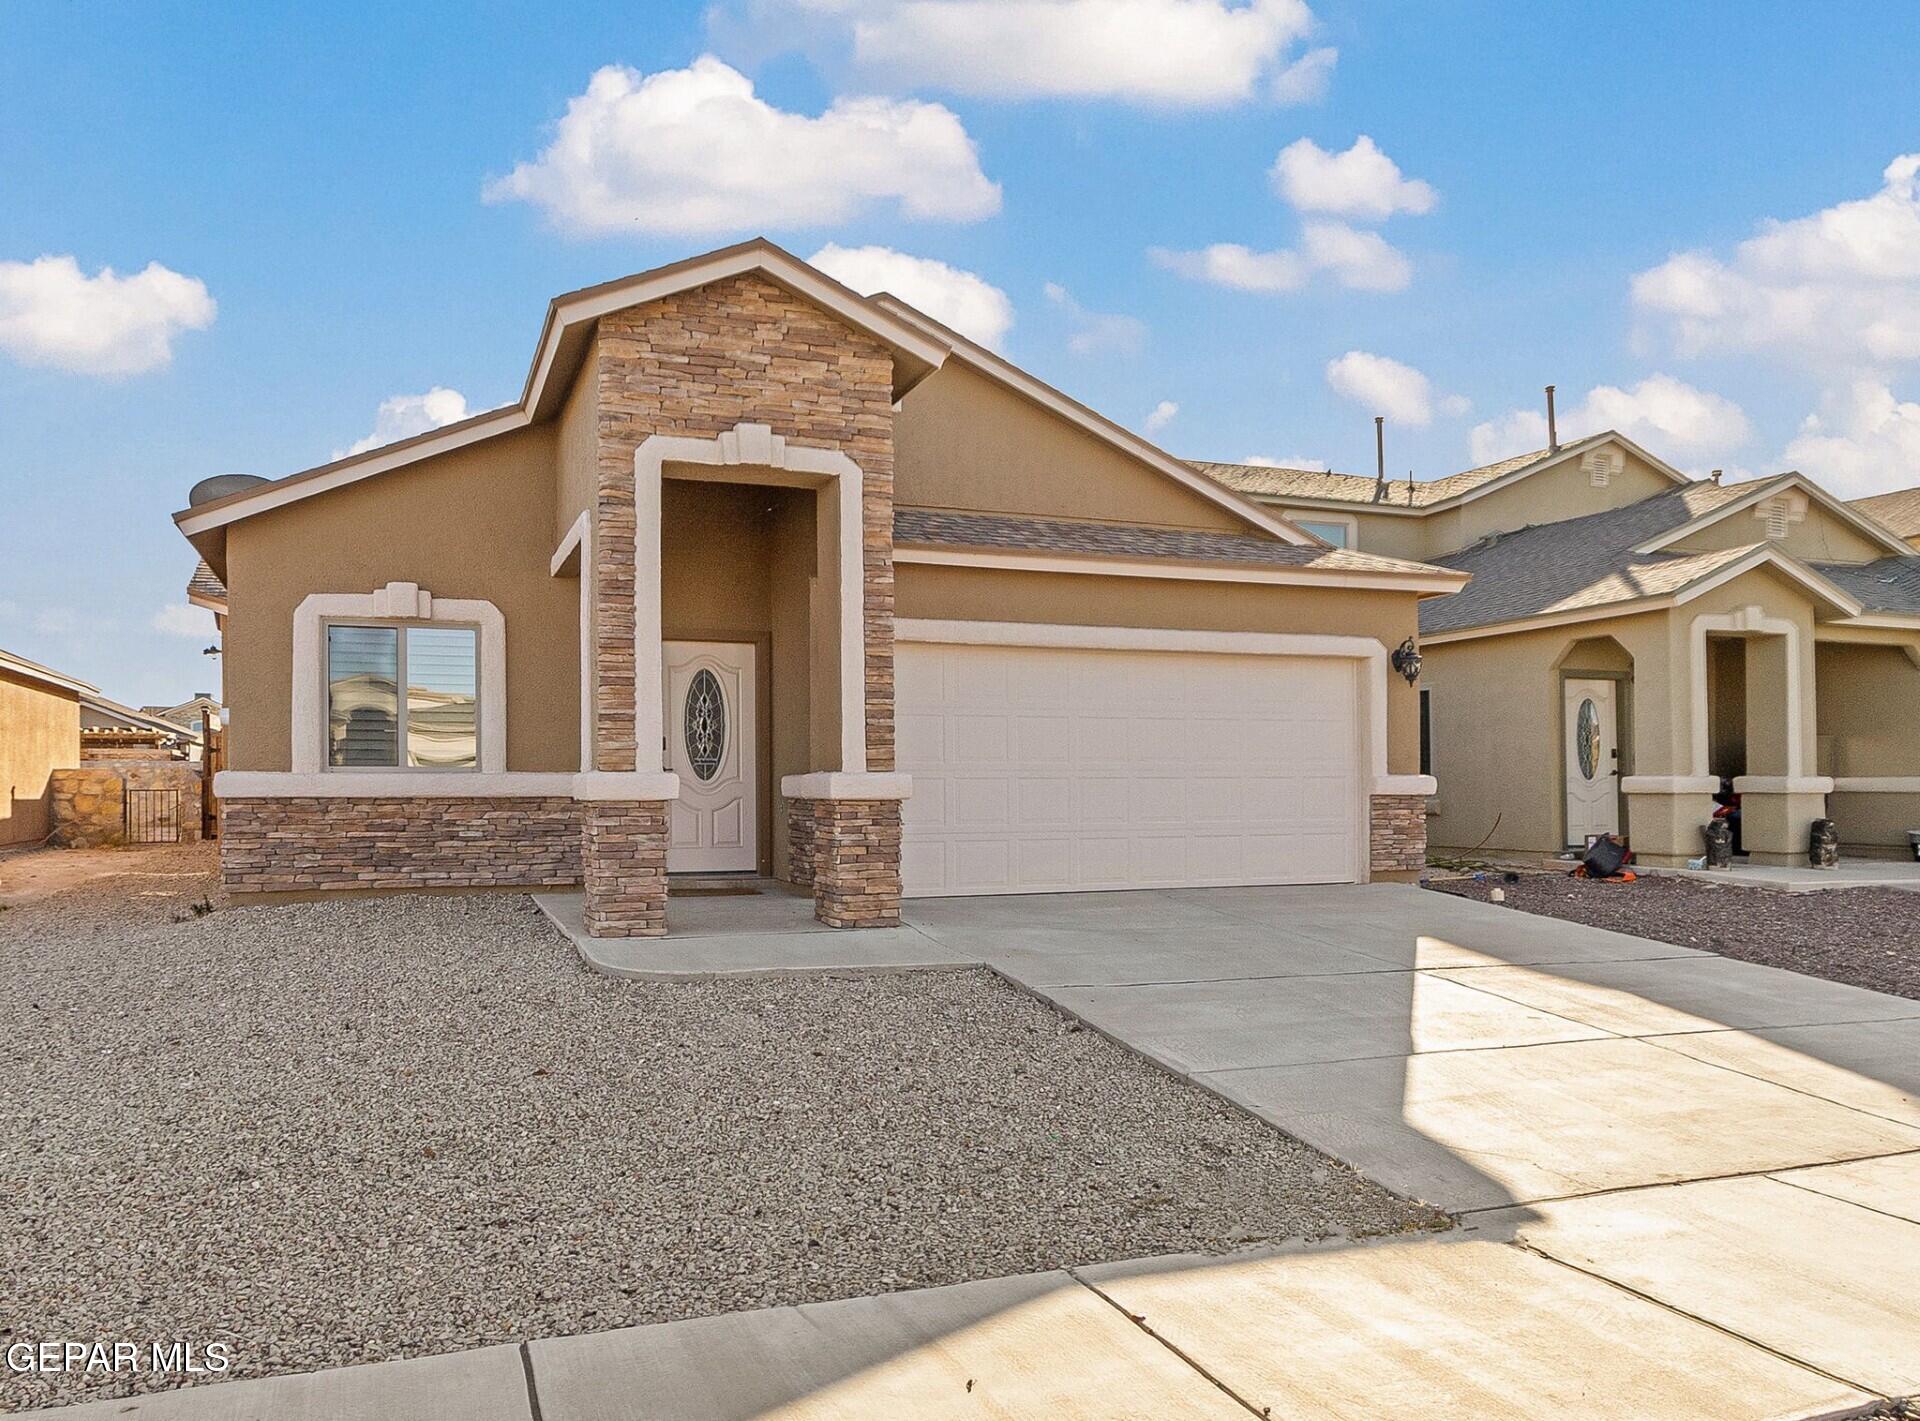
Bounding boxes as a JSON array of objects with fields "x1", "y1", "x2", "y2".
[{"x1": 1427, "y1": 872, "x2": 1920, "y2": 999}]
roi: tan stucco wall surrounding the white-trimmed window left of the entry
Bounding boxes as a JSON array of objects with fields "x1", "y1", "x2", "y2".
[{"x1": 223, "y1": 424, "x2": 580, "y2": 770}]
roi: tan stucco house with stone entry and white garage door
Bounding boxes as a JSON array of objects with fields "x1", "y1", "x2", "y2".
[{"x1": 177, "y1": 242, "x2": 1465, "y2": 935}]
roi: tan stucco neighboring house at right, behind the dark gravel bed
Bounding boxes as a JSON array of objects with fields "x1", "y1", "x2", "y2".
[{"x1": 1200, "y1": 432, "x2": 1920, "y2": 864}]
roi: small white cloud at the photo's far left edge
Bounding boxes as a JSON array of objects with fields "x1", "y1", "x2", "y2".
[{"x1": 0, "y1": 257, "x2": 217, "y2": 374}]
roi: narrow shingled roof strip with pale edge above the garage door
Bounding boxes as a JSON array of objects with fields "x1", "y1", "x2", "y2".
[{"x1": 893, "y1": 509, "x2": 1465, "y2": 597}]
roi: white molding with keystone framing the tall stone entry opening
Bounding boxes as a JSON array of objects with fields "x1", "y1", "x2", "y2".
[{"x1": 634, "y1": 424, "x2": 866, "y2": 774}]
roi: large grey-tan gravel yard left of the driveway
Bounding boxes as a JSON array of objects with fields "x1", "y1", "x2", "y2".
[{"x1": 0, "y1": 851, "x2": 1446, "y2": 1409}]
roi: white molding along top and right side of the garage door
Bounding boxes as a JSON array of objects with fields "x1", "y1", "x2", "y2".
[{"x1": 893, "y1": 616, "x2": 1405, "y2": 806}]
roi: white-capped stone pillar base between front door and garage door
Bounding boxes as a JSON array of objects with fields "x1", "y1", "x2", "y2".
[{"x1": 780, "y1": 770, "x2": 914, "y2": 927}]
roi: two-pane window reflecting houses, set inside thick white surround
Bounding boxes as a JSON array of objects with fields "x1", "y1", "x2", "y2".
[{"x1": 326, "y1": 622, "x2": 480, "y2": 770}]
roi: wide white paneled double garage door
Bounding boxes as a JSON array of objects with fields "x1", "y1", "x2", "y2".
[{"x1": 895, "y1": 643, "x2": 1361, "y2": 897}]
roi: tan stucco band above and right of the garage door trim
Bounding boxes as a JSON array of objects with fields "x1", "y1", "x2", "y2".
[{"x1": 897, "y1": 563, "x2": 1421, "y2": 774}]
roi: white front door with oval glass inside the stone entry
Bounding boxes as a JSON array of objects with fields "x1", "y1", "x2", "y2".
[{"x1": 660, "y1": 641, "x2": 760, "y2": 874}]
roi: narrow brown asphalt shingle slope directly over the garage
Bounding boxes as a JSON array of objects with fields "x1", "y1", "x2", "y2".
[{"x1": 893, "y1": 509, "x2": 1432, "y2": 572}]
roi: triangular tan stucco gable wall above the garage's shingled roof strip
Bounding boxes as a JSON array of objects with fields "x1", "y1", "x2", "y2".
[{"x1": 895, "y1": 359, "x2": 1246, "y2": 530}]
